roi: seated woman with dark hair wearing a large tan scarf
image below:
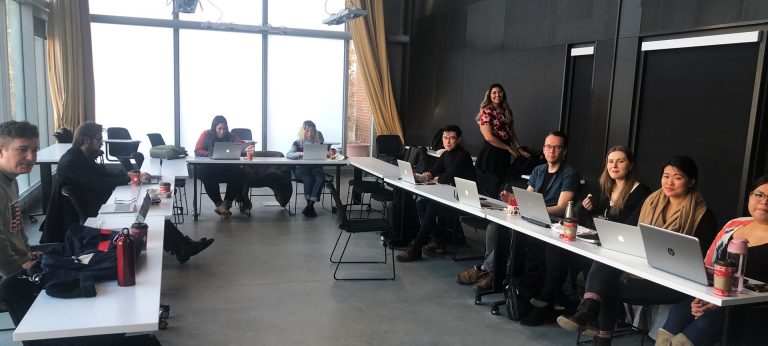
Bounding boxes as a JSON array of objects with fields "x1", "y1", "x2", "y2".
[{"x1": 558, "y1": 156, "x2": 717, "y2": 345}]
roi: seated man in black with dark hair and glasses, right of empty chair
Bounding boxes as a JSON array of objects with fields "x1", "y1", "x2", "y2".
[{"x1": 397, "y1": 125, "x2": 475, "y2": 262}]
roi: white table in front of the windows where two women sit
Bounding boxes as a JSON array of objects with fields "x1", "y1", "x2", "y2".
[{"x1": 187, "y1": 156, "x2": 349, "y2": 221}]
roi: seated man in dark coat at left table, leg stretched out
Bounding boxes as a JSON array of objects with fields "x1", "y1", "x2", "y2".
[{"x1": 40, "y1": 122, "x2": 213, "y2": 263}]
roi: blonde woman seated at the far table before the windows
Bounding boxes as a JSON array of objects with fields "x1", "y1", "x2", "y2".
[{"x1": 285, "y1": 120, "x2": 325, "y2": 217}]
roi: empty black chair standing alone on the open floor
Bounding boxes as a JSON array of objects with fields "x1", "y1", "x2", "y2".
[{"x1": 326, "y1": 182, "x2": 395, "y2": 280}]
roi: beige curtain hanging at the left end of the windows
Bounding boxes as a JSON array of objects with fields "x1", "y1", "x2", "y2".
[{"x1": 48, "y1": 0, "x2": 96, "y2": 131}]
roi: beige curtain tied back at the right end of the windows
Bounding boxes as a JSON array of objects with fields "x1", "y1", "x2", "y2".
[{"x1": 349, "y1": 0, "x2": 403, "y2": 140}]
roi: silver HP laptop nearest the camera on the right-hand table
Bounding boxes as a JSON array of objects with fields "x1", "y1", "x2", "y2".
[{"x1": 640, "y1": 223, "x2": 709, "y2": 286}]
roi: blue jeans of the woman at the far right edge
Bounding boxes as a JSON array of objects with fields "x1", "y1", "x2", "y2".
[{"x1": 664, "y1": 297, "x2": 725, "y2": 346}]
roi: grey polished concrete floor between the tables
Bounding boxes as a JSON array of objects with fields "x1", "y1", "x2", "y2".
[{"x1": 0, "y1": 174, "x2": 649, "y2": 345}]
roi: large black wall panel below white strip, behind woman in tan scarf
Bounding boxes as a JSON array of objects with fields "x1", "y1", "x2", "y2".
[{"x1": 636, "y1": 43, "x2": 758, "y2": 222}]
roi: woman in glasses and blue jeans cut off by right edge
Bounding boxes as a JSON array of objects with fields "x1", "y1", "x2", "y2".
[{"x1": 656, "y1": 175, "x2": 768, "y2": 345}]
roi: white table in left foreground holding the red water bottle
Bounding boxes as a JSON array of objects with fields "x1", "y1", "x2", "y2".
[{"x1": 13, "y1": 214, "x2": 165, "y2": 341}]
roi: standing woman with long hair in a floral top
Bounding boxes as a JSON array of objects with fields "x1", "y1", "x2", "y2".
[{"x1": 475, "y1": 83, "x2": 530, "y2": 196}]
